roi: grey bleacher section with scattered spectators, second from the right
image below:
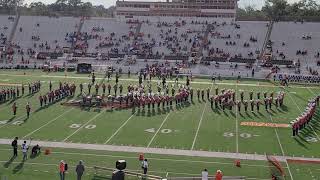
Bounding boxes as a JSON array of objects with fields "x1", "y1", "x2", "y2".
[{"x1": 204, "y1": 21, "x2": 268, "y2": 59}]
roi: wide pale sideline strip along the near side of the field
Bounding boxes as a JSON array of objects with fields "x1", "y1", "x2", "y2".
[{"x1": 0, "y1": 139, "x2": 320, "y2": 162}]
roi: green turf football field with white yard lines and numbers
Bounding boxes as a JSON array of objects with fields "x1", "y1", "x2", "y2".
[{"x1": 0, "y1": 70, "x2": 320, "y2": 179}]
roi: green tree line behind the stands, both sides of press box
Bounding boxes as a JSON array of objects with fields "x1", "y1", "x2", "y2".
[{"x1": 0, "y1": 0, "x2": 320, "y2": 21}]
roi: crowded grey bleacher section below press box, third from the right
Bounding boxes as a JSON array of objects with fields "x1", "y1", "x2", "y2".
[{"x1": 135, "y1": 21, "x2": 206, "y2": 56}]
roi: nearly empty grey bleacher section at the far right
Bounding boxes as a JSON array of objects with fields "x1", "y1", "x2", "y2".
[{"x1": 270, "y1": 22, "x2": 320, "y2": 65}]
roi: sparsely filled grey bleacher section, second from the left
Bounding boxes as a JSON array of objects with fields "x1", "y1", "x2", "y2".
[{"x1": 13, "y1": 16, "x2": 79, "y2": 51}]
